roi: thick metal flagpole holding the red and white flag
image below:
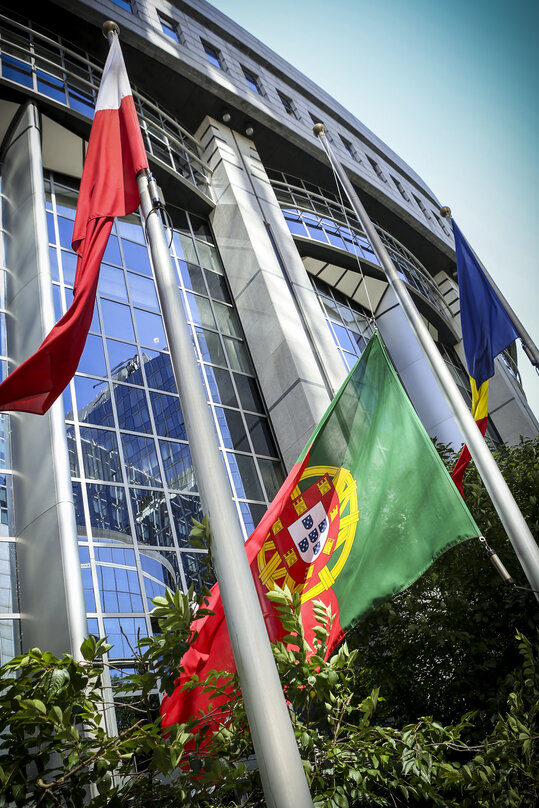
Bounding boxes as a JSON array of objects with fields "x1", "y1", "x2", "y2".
[{"x1": 103, "y1": 22, "x2": 313, "y2": 808}]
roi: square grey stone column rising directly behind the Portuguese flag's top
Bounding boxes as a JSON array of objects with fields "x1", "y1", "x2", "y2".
[{"x1": 196, "y1": 118, "x2": 344, "y2": 468}]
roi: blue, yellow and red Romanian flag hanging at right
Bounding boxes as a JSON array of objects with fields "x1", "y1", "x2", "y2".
[{"x1": 451, "y1": 221, "x2": 518, "y2": 494}]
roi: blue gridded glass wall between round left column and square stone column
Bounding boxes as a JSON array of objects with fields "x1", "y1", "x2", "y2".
[{"x1": 46, "y1": 176, "x2": 283, "y2": 658}]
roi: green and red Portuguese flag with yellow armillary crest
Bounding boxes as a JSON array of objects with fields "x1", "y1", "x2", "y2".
[{"x1": 161, "y1": 333, "x2": 480, "y2": 727}]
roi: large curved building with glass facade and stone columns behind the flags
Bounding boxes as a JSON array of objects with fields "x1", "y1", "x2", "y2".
[{"x1": 0, "y1": 0, "x2": 538, "y2": 716}]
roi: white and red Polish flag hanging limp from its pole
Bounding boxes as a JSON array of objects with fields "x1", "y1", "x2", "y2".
[{"x1": 0, "y1": 36, "x2": 148, "y2": 415}]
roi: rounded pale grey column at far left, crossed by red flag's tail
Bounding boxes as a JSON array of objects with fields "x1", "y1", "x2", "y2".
[{"x1": 1, "y1": 102, "x2": 87, "y2": 656}]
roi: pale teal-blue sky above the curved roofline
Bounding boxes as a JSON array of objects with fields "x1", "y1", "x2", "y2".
[{"x1": 212, "y1": 0, "x2": 539, "y2": 417}]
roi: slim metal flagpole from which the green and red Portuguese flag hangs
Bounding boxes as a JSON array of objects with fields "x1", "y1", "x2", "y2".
[{"x1": 313, "y1": 123, "x2": 539, "y2": 600}]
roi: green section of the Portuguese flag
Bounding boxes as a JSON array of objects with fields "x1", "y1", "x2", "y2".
[{"x1": 303, "y1": 333, "x2": 481, "y2": 629}]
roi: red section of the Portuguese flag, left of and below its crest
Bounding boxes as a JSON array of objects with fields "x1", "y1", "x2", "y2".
[{"x1": 161, "y1": 453, "x2": 344, "y2": 730}]
